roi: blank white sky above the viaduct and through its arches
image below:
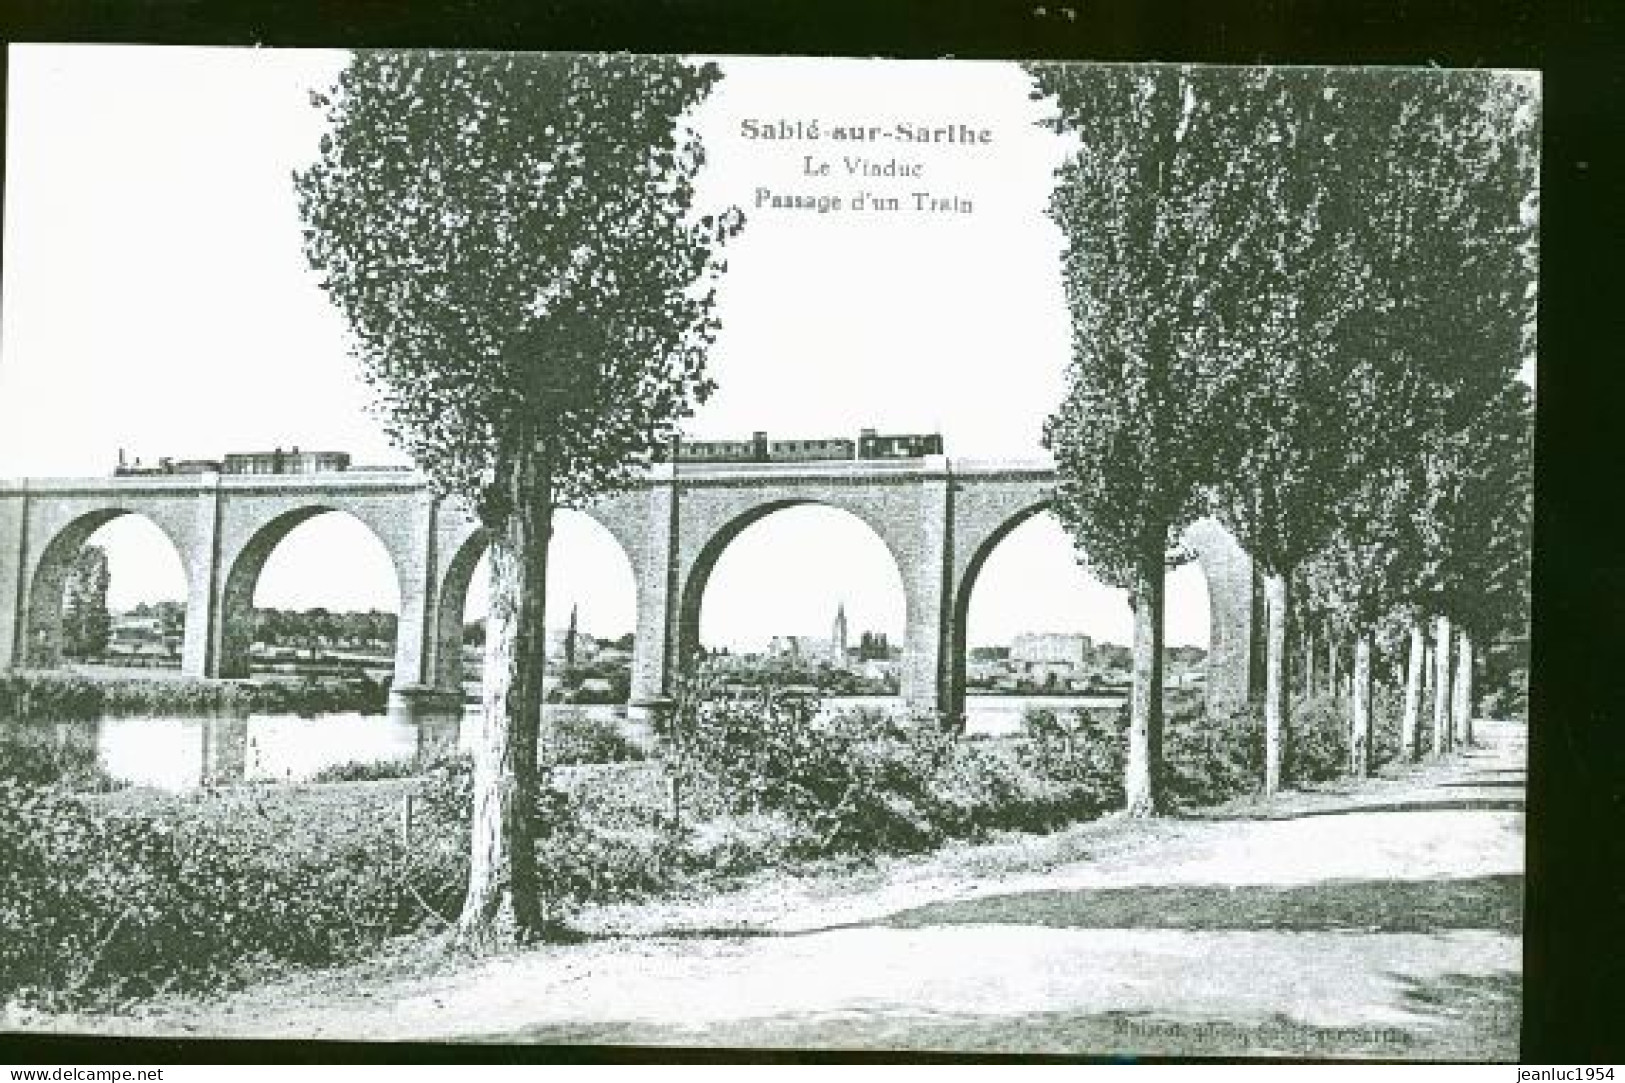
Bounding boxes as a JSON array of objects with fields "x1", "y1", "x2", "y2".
[{"x1": 0, "y1": 46, "x2": 1207, "y2": 646}]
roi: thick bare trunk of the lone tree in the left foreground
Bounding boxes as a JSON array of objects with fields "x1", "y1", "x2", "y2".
[{"x1": 458, "y1": 439, "x2": 553, "y2": 943}]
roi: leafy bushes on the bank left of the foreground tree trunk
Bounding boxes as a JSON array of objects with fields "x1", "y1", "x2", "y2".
[{"x1": 0, "y1": 781, "x2": 466, "y2": 1008}]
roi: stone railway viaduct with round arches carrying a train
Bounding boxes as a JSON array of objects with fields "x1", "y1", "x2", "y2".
[{"x1": 0, "y1": 455, "x2": 1261, "y2": 712}]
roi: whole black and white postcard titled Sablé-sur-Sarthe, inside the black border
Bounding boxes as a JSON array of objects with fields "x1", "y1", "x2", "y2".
[{"x1": 0, "y1": 44, "x2": 1542, "y2": 1062}]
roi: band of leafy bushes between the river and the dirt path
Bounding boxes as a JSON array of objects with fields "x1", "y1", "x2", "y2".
[{"x1": 0, "y1": 669, "x2": 1430, "y2": 1008}]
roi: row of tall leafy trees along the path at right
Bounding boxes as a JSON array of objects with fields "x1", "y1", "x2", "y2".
[{"x1": 1032, "y1": 65, "x2": 1537, "y2": 815}]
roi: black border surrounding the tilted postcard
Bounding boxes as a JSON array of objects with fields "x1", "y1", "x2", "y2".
[{"x1": 0, "y1": 0, "x2": 1625, "y2": 1063}]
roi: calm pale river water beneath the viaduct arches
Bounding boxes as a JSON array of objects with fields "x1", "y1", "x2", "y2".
[{"x1": 0, "y1": 696, "x2": 1121, "y2": 792}]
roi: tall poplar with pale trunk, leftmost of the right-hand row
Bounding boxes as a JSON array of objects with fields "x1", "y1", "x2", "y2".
[{"x1": 1030, "y1": 65, "x2": 1258, "y2": 815}]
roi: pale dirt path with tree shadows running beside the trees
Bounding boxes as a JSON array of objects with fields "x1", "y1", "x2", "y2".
[{"x1": 47, "y1": 724, "x2": 1524, "y2": 1060}]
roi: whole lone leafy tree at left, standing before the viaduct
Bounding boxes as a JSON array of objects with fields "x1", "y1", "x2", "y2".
[{"x1": 296, "y1": 50, "x2": 738, "y2": 942}]
